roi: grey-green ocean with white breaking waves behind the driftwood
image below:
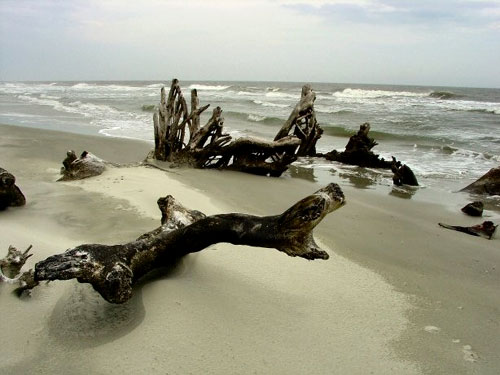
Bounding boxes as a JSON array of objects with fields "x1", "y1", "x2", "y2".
[{"x1": 0, "y1": 80, "x2": 500, "y2": 207}]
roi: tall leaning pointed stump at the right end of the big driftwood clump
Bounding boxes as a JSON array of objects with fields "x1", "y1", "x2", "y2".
[{"x1": 274, "y1": 85, "x2": 323, "y2": 156}]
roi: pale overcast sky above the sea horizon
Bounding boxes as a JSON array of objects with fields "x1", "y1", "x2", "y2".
[{"x1": 0, "y1": 0, "x2": 500, "y2": 88}]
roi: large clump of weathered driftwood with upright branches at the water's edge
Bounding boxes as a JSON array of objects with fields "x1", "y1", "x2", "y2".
[{"x1": 150, "y1": 79, "x2": 321, "y2": 177}]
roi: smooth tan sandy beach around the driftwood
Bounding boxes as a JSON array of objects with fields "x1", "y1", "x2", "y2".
[{"x1": 0, "y1": 125, "x2": 500, "y2": 374}]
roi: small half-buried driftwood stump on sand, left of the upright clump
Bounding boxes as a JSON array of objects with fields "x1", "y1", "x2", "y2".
[{"x1": 58, "y1": 150, "x2": 106, "y2": 181}]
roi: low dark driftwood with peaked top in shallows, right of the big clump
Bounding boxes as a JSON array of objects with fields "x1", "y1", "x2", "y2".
[{"x1": 322, "y1": 122, "x2": 392, "y2": 169}]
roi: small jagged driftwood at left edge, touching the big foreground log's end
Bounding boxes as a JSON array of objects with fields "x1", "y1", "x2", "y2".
[{"x1": 0, "y1": 245, "x2": 38, "y2": 293}]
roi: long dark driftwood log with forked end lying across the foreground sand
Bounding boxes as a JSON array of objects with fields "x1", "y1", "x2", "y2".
[{"x1": 35, "y1": 184, "x2": 345, "y2": 303}]
